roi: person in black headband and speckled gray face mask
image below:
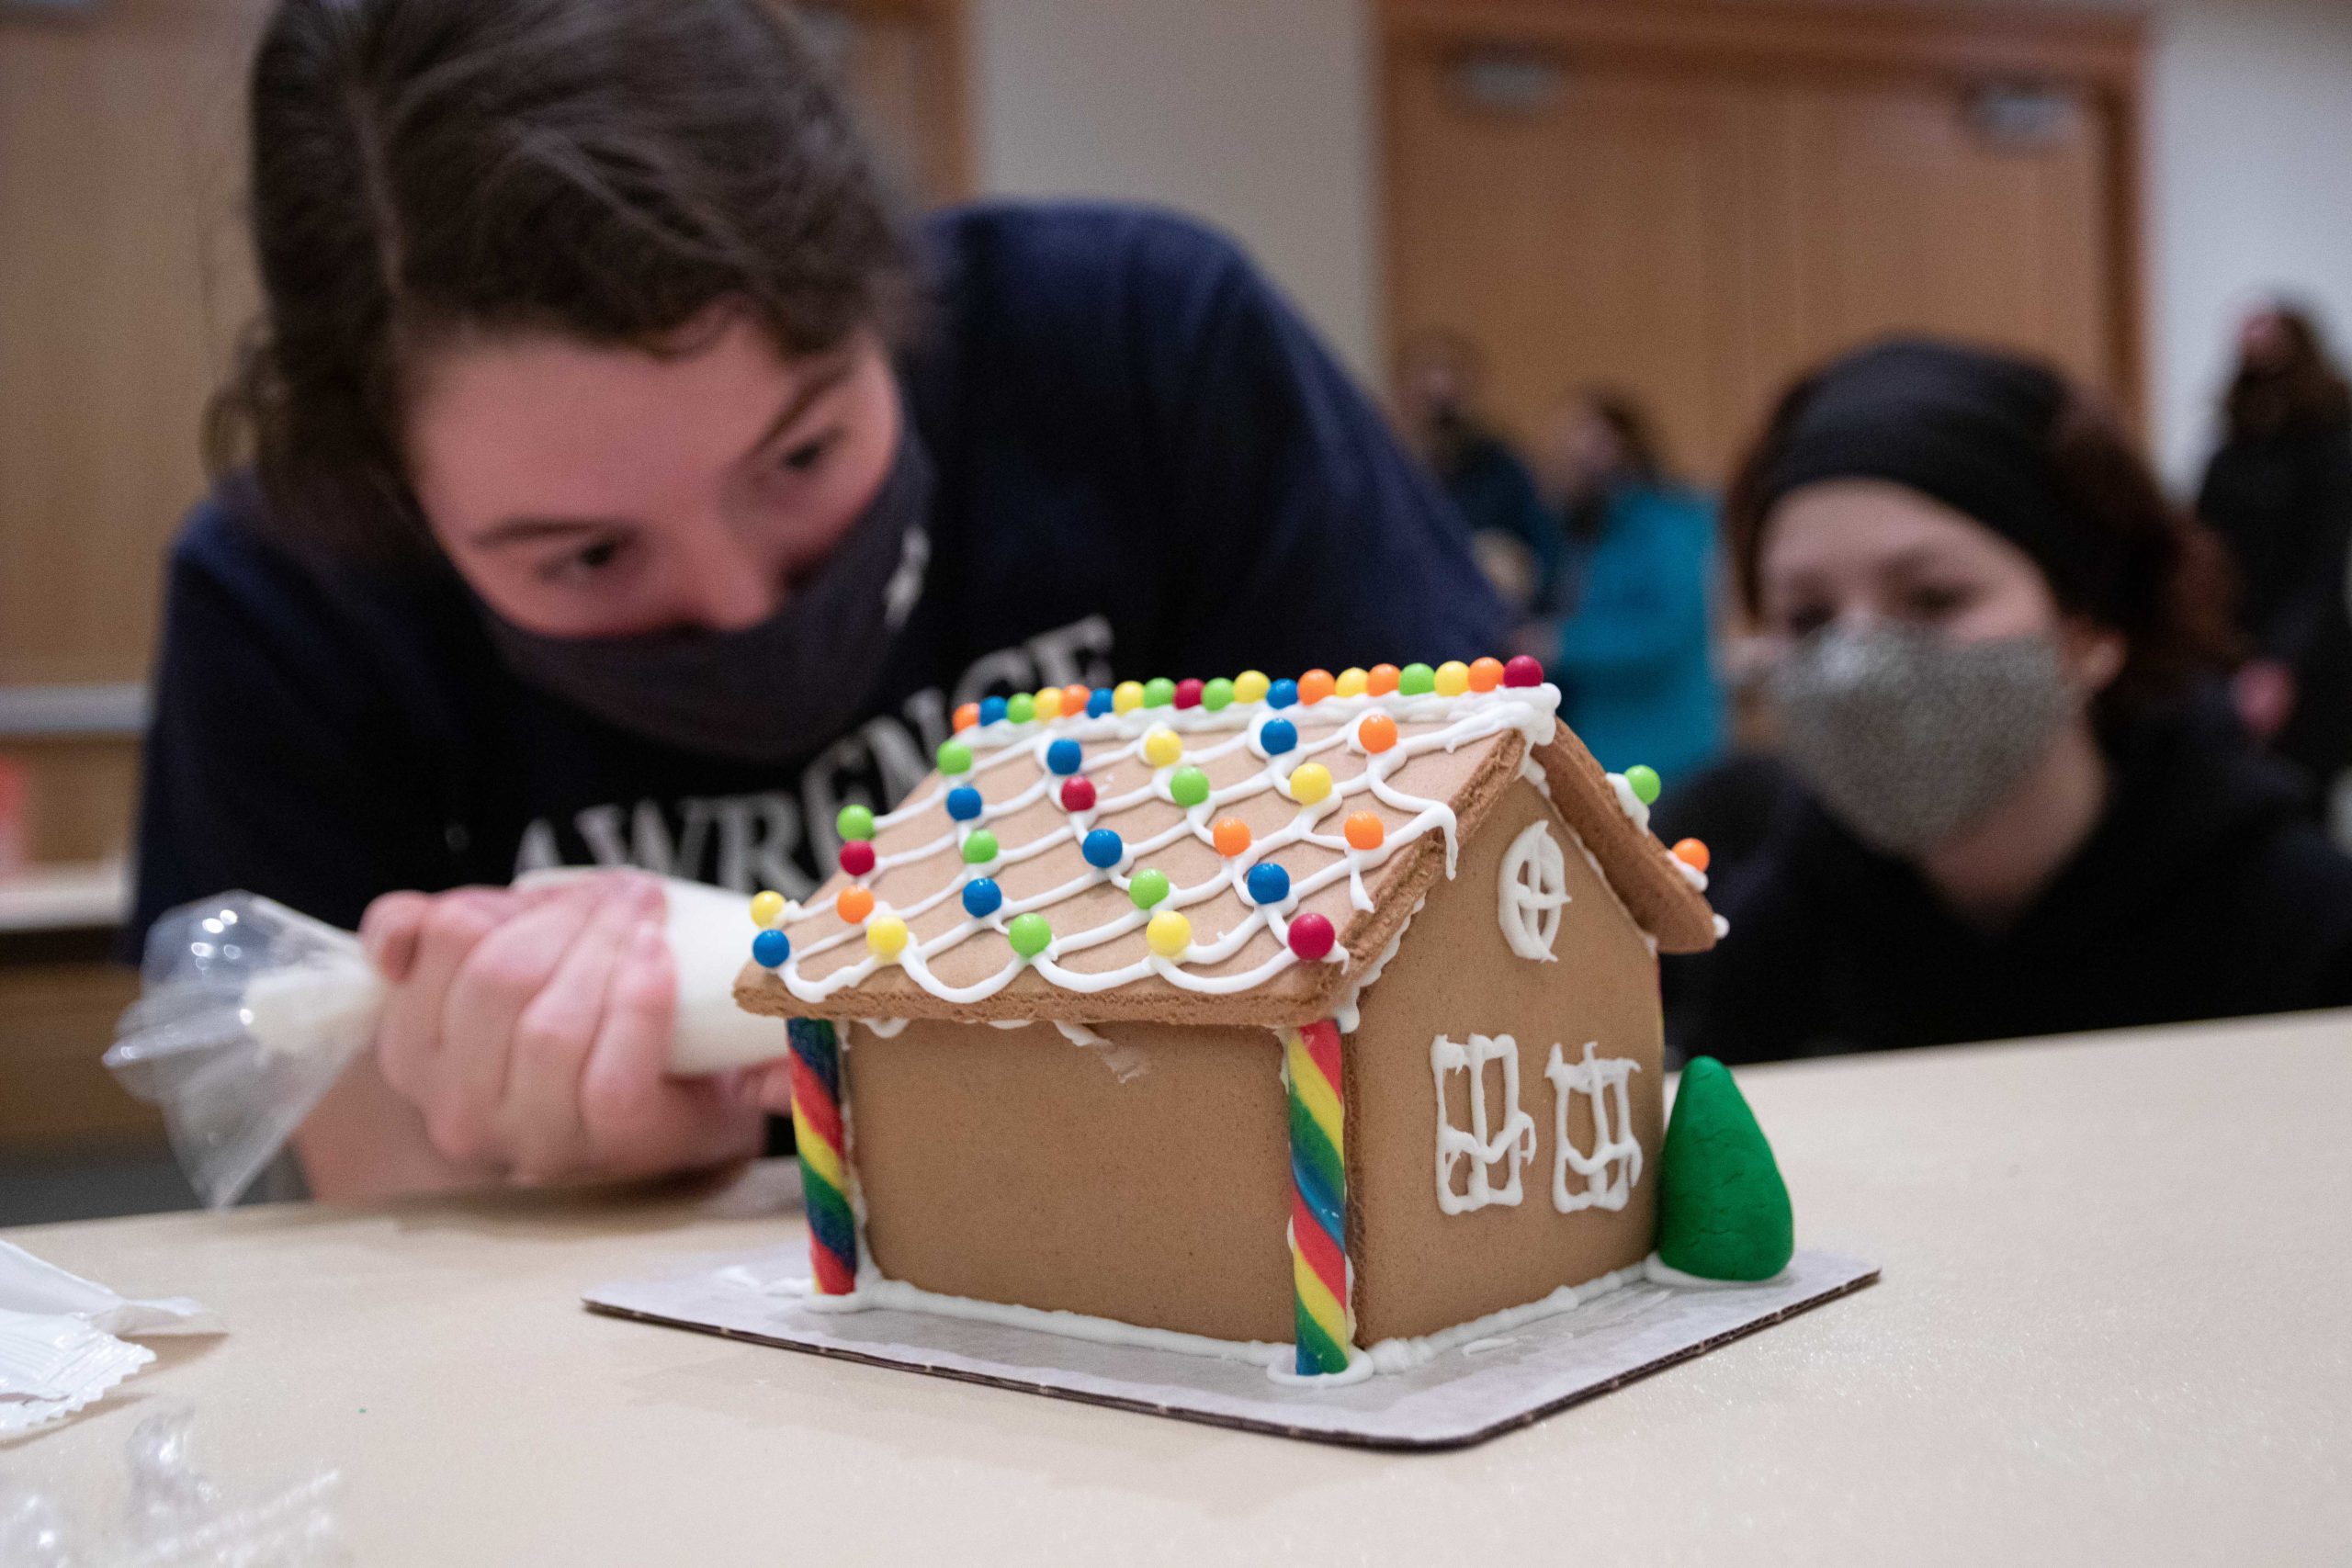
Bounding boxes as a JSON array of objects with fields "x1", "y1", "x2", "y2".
[{"x1": 1684, "y1": 341, "x2": 2352, "y2": 1063}]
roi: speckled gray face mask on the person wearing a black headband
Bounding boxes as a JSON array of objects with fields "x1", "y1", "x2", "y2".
[{"x1": 1771, "y1": 627, "x2": 2075, "y2": 856}]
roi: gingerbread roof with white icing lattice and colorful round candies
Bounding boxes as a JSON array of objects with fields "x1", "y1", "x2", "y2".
[{"x1": 736, "y1": 660, "x2": 1714, "y2": 1025}]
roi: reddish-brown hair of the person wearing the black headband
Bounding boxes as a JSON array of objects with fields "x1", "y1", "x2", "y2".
[{"x1": 1724, "y1": 350, "x2": 2239, "y2": 722}]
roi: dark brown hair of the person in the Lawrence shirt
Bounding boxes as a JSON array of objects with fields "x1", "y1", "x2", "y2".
[{"x1": 205, "y1": 0, "x2": 910, "y2": 559}]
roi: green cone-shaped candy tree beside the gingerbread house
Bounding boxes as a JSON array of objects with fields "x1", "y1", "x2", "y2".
[{"x1": 1658, "y1": 1055, "x2": 1797, "y2": 1281}]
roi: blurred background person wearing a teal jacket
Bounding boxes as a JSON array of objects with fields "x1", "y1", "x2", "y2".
[{"x1": 1536, "y1": 388, "x2": 1726, "y2": 783}]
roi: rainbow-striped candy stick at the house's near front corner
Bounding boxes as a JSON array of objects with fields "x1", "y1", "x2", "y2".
[{"x1": 1282, "y1": 1021, "x2": 1355, "y2": 1378}]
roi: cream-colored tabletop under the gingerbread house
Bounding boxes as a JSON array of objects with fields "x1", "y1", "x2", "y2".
[{"x1": 0, "y1": 1013, "x2": 2352, "y2": 1568}]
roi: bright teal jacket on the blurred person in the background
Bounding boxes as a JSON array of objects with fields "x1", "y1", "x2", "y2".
[{"x1": 1553, "y1": 487, "x2": 1726, "y2": 787}]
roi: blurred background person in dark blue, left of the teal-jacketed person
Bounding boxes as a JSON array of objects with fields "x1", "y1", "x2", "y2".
[{"x1": 1397, "y1": 329, "x2": 1566, "y2": 620}]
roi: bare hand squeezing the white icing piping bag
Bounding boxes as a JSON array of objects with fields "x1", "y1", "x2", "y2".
[{"x1": 360, "y1": 872, "x2": 760, "y2": 1182}]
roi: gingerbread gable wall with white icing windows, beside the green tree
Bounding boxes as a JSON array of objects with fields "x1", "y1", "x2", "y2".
[{"x1": 1348, "y1": 781, "x2": 1663, "y2": 1345}]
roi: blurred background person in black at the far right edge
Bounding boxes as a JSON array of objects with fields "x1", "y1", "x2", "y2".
[{"x1": 2197, "y1": 303, "x2": 2352, "y2": 827}]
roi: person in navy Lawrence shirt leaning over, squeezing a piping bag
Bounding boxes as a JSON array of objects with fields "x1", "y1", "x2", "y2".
[{"x1": 134, "y1": 0, "x2": 1505, "y2": 1197}]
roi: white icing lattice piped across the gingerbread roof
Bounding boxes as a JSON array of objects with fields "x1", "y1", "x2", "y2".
[{"x1": 776, "y1": 686, "x2": 1559, "y2": 1004}]
